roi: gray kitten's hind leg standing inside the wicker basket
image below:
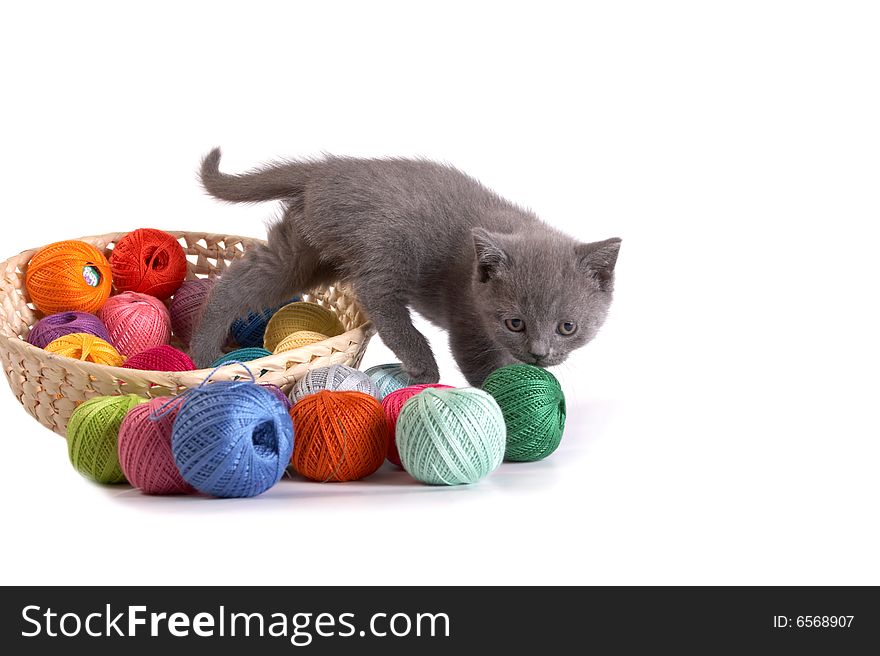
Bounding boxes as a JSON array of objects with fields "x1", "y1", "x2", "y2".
[{"x1": 191, "y1": 225, "x2": 326, "y2": 368}]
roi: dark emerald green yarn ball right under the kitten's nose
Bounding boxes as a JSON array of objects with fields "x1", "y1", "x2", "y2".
[{"x1": 483, "y1": 364, "x2": 565, "y2": 462}]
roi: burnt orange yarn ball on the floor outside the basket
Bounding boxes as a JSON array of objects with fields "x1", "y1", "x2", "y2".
[{"x1": 290, "y1": 390, "x2": 388, "y2": 483}]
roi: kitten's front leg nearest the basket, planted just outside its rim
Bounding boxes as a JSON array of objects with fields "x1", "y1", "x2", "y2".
[{"x1": 355, "y1": 281, "x2": 440, "y2": 384}]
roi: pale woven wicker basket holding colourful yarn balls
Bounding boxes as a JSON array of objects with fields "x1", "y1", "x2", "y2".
[{"x1": 0, "y1": 231, "x2": 375, "y2": 435}]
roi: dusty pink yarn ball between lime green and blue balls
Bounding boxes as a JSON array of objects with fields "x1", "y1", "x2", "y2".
[{"x1": 118, "y1": 396, "x2": 195, "y2": 494}]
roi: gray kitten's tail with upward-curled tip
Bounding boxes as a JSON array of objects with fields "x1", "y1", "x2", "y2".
[{"x1": 199, "y1": 148, "x2": 309, "y2": 203}]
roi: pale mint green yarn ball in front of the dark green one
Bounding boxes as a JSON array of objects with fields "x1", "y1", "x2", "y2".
[{"x1": 396, "y1": 388, "x2": 505, "y2": 485}]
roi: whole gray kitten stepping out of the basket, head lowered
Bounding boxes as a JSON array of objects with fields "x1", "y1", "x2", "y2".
[{"x1": 192, "y1": 149, "x2": 620, "y2": 386}]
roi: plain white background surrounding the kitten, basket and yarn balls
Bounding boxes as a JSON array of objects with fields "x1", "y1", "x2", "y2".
[{"x1": 0, "y1": 1, "x2": 880, "y2": 584}]
